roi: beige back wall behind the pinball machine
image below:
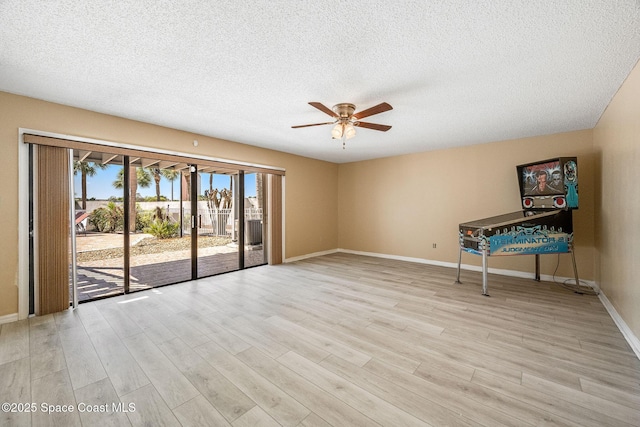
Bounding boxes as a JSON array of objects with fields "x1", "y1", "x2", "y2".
[{"x1": 338, "y1": 130, "x2": 594, "y2": 280}]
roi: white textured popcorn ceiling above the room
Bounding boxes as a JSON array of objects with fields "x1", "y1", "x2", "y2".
[{"x1": 0, "y1": 0, "x2": 640, "y2": 163}]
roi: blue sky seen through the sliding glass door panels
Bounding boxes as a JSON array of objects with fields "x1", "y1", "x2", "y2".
[{"x1": 74, "y1": 165, "x2": 256, "y2": 200}]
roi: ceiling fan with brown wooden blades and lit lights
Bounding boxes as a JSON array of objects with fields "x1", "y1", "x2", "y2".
[{"x1": 291, "y1": 102, "x2": 393, "y2": 149}]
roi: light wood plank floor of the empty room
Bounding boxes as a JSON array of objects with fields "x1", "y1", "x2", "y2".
[{"x1": 0, "y1": 254, "x2": 640, "y2": 427}]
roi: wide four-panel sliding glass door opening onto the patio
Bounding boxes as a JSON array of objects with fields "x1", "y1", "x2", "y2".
[{"x1": 25, "y1": 136, "x2": 276, "y2": 313}]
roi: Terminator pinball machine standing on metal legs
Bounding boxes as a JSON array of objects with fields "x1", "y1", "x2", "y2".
[{"x1": 455, "y1": 157, "x2": 579, "y2": 296}]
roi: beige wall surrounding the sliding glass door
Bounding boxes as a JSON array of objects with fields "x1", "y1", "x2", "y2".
[{"x1": 0, "y1": 92, "x2": 338, "y2": 316}]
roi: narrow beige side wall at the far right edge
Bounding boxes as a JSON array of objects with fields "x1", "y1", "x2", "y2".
[{"x1": 593, "y1": 60, "x2": 640, "y2": 337}]
